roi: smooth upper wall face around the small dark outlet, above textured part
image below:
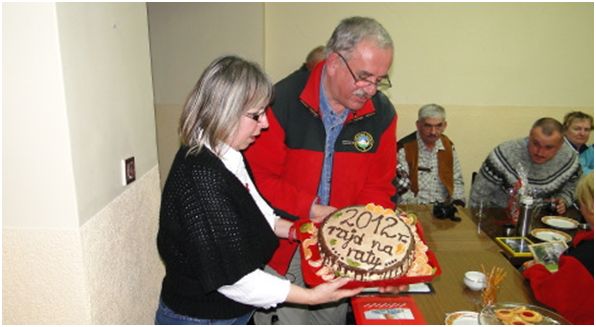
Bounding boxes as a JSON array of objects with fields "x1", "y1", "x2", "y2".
[{"x1": 56, "y1": 3, "x2": 157, "y2": 224}]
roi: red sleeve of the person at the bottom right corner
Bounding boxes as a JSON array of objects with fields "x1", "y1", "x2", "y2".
[{"x1": 523, "y1": 255, "x2": 594, "y2": 325}]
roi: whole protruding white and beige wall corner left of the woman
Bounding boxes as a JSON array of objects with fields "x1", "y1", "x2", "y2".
[{"x1": 2, "y1": 3, "x2": 163, "y2": 324}]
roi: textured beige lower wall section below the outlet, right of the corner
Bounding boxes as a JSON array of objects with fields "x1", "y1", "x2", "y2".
[{"x1": 79, "y1": 166, "x2": 165, "y2": 325}]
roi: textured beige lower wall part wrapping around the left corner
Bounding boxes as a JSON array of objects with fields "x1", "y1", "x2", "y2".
[{"x1": 2, "y1": 166, "x2": 164, "y2": 325}]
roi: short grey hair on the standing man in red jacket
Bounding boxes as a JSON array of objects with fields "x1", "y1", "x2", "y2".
[{"x1": 326, "y1": 16, "x2": 393, "y2": 57}]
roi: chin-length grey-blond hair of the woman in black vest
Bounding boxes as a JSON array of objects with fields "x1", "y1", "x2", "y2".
[{"x1": 179, "y1": 56, "x2": 273, "y2": 154}]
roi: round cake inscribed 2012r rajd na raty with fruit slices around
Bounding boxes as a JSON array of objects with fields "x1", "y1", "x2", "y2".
[{"x1": 302, "y1": 204, "x2": 433, "y2": 281}]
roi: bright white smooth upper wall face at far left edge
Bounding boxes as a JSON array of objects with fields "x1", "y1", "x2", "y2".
[{"x1": 2, "y1": 4, "x2": 78, "y2": 228}]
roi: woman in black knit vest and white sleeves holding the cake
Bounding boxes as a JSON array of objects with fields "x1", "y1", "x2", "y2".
[{"x1": 155, "y1": 56, "x2": 361, "y2": 324}]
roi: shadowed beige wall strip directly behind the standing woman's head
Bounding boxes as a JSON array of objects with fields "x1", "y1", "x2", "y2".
[{"x1": 147, "y1": 3, "x2": 265, "y2": 186}]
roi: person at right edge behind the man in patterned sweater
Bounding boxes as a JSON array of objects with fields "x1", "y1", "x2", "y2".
[{"x1": 563, "y1": 111, "x2": 594, "y2": 175}]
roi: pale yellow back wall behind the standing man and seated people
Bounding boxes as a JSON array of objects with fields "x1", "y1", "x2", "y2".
[{"x1": 265, "y1": 3, "x2": 594, "y2": 197}]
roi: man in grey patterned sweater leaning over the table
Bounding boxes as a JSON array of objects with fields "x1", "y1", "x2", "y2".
[{"x1": 470, "y1": 117, "x2": 581, "y2": 214}]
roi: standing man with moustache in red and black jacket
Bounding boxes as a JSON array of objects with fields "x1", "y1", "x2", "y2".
[{"x1": 244, "y1": 17, "x2": 397, "y2": 325}]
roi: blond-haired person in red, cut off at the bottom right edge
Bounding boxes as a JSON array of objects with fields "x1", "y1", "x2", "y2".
[{"x1": 523, "y1": 172, "x2": 594, "y2": 325}]
